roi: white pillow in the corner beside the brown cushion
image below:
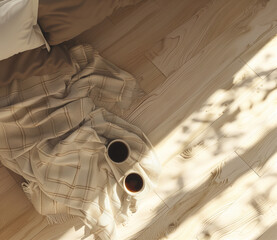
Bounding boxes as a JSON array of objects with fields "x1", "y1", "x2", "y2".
[{"x1": 0, "y1": 0, "x2": 50, "y2": 60}]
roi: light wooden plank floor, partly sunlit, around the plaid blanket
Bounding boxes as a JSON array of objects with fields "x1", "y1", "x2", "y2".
[{"x1": 0, "y1": 0, "x2": 277, "y2": 240}]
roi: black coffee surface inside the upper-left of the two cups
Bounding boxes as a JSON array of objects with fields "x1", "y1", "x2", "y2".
[{"x1": 108, "y1": 142, "x2": 129, "y2": 163}]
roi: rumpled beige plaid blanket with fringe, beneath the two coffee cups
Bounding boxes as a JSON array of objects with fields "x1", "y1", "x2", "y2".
[{"x1": 0, "y1": 46, "x2": 160, "y2": 239}]
